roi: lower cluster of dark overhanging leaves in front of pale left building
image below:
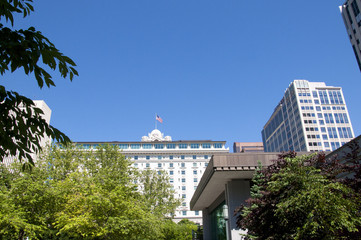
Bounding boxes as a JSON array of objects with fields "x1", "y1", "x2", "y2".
[{"x1": 0, "y1": 86, "x2": 70, "y2": 166}]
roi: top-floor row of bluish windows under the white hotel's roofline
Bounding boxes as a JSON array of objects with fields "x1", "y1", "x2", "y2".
[{"x1": 78, "y1": 143, "x2": 223, "y2": 149}]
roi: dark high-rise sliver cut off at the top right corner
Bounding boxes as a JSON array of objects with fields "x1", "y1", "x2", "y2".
[{"x1": 340, "y1": 0, "x2": 361, "y2": 71}]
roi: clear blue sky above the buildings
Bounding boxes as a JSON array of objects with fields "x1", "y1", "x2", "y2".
[{"x1": 2, "y1": 0, "x2": 361, "y2": 148}]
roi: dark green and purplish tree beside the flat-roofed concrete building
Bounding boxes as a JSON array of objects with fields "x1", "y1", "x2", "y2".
[{"x1": 236, "y1": 147, "x2": 361, "y2": 239}]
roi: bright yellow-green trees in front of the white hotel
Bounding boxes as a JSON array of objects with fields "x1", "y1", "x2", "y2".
[{"x1": 0, "y1": 145, "x2": 184, "y2": 240}]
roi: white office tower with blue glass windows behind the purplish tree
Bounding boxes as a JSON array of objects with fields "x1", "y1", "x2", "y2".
[{"x1": 262, "y1": 80, "x2": 354, "y2": 152}]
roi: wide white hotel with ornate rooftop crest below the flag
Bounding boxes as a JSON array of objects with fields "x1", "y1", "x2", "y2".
[{"x1": 77, "y1": 129, "x2": 229, "y2": 224}]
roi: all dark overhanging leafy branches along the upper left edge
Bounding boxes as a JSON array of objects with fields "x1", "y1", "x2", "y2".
[{"x1": 0, "y1": 0, "x2": 78, "y2": 165}]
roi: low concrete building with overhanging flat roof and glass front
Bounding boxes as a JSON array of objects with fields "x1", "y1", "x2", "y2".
[{"x1": 190, "y1": 153, "x2": 278, "y2": 240}]
